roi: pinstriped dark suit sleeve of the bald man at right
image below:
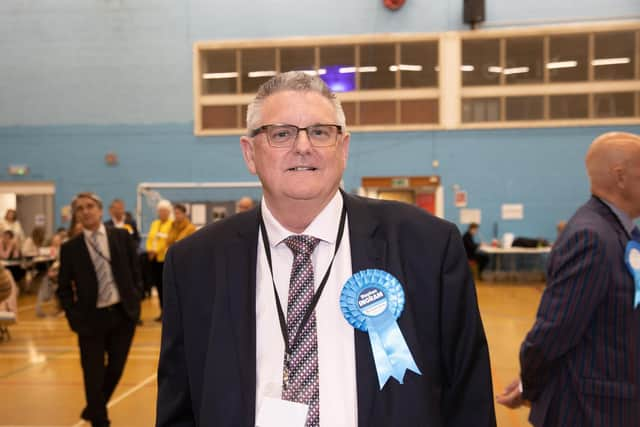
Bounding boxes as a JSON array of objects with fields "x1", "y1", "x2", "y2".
[{"x1": 520, "y1": 230, "x2": 610, "y2": 400}]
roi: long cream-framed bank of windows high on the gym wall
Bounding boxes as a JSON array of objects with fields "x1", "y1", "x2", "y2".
[{"x1": 193, "y1": 21, "x2": 640, "y2": 135}]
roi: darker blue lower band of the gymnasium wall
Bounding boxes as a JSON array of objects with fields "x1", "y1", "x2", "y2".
[{"x1": 0, "y1": 124, "x2": 640, "y2": 239}]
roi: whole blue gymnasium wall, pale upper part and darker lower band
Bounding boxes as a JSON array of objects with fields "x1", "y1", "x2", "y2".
[{"x1": 0, "y1": 0, "x2": 640, "y2": 237}]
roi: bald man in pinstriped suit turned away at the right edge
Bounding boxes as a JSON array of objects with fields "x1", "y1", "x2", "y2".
[{"x1": 498, "y1": 132, "x2": 640, "y2": 427}]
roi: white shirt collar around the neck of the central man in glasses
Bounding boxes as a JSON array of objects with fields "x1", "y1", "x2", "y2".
[{"x1": 260, "y1": 191, "x2": 344, "y2": 248}]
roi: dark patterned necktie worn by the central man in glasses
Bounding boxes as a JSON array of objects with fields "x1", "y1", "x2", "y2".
[{"x1": 282, "y1": 235, "x2": 320, "y2": 427}]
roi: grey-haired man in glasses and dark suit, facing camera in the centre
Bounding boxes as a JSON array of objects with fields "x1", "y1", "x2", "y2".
[{"x1": 157, "y1": 72, "x2": 495, "y2": 427}]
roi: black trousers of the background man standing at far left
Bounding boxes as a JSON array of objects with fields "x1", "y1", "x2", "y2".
[{"x1": 78, "y1": 304, "x2": 136, "y2": 427}]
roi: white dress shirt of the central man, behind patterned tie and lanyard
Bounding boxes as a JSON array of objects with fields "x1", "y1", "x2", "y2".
[{"x1": 256, "y1": 192, "x2": 358, "y2": 427}]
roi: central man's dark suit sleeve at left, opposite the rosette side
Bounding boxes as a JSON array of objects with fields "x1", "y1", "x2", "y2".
[{"x1": 156, "y1": 251, "x2": 196, "y2": 427}]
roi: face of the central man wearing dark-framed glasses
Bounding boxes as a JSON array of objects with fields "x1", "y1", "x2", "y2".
[{"x1": 240, "y1": 91, "x2": 349, "y2": 209}]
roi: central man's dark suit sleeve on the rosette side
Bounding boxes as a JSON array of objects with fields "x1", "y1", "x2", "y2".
[{"x1": 440, "y1": 226, "x2": 496, "y2": 427}]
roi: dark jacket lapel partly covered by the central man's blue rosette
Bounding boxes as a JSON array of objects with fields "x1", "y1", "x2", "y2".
[{"x1": 343, "y1": 193, "x2": 387, "y2": 426}]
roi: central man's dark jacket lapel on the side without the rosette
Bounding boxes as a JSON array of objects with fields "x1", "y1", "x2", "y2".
[{"x1": 226, "y1": 210, "x2": 258, "y2": 425}]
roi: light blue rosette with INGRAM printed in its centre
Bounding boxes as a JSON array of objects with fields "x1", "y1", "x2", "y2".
[{"x1": 340, "y1": 269, "x2": 422, "y2": 390}]
